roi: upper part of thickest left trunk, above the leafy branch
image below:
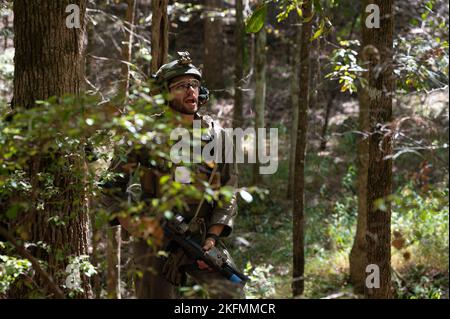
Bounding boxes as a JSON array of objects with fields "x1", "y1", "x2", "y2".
[{"x1": 14, "y1": 0, "x2": 86, "y2": 108}]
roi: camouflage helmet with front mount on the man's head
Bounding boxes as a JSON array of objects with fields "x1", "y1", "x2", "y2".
[{"x1": 154, "y1": 52, "x2": 202, "y2": 85}]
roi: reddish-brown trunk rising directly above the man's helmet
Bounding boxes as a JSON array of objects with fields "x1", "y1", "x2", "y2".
[{"x1": 150, "y1": 0, "x2": 169, "y2": 74}]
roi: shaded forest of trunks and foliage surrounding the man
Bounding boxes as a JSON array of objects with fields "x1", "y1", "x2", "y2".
[{"x1": 0, "y1": 0, "x2": 449, "y2": 299}]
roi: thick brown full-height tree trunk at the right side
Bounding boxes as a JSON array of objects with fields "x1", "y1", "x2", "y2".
[{"x1": 362, "y1": 0, "x2": 395, "y2": 298}]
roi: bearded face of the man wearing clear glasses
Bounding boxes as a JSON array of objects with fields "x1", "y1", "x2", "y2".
[{"x1": 169, "y1": 75, "x2": 200, "y2": 115}]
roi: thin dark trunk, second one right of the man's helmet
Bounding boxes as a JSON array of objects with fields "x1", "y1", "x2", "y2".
[{"x1": 233, "y1": 0, "x2": 245, "y2": 127}]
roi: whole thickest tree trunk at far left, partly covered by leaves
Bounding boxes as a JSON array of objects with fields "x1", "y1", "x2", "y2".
[{"x1": 14, "y1": 0, "x2": 91, "y2": 297}]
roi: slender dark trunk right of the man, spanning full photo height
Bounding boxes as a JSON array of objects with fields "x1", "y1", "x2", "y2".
[{"x1": 292, "y1": 1, "x2": 312, "y2": 297}]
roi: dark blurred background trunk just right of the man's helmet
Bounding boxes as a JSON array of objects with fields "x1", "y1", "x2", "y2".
[{"x1": 203, "y1": 0, "x2": 225, "y2": 90}]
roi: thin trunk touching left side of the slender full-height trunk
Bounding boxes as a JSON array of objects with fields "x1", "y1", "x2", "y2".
[{"x1": 287, "y1": 26, "x2": 301, "y2": 199}]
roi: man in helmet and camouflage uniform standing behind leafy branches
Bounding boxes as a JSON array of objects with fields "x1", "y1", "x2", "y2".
[{"x1": 105, "y1": 53, "x2": 244, "y2": 298}]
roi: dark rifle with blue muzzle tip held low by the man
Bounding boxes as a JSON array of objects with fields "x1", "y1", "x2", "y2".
[{"x1": 162, "y1": 215, "x2": 249, "y2": 285}]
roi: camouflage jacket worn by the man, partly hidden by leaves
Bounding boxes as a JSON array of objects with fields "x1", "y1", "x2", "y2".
[{"x1": 102, "y1": 114, "x2": 238, "y2": 237}]
